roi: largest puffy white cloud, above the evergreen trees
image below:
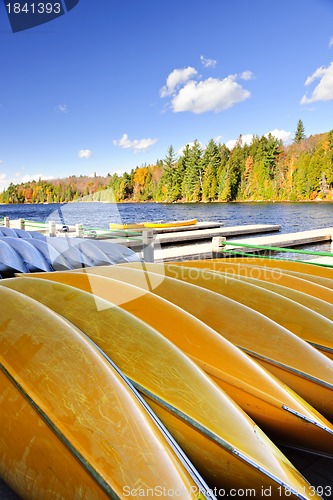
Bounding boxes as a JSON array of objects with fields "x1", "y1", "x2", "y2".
[{"x1": 171, "y1": 75, "x2": 251, "y2": 114}]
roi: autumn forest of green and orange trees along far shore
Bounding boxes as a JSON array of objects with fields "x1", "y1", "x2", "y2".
[{"x1": 0, "y1": 130, "x2": 333, "y2": 203}]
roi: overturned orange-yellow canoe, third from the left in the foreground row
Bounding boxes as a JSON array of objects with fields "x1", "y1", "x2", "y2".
[{"x1": 7, "y1": 273, "x2": 333, "y2": 453}]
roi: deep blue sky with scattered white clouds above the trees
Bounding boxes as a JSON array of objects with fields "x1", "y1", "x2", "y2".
[{"x1": 0, "y1": 0, "x2": 333, "y2": 189}]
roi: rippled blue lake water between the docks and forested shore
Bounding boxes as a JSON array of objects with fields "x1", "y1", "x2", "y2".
[{"x1": 0, "y1": 202, "x2": 333, "y2": 258}]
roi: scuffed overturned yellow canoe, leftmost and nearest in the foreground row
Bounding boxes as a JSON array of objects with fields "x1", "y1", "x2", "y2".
[{"x1": 0, "y1": 286, "x2": 202, "y2": 499}]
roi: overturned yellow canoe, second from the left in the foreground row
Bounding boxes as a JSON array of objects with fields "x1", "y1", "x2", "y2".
[{"x1": 2, "y1": 278, "x2": 322, "y2": 498}]
